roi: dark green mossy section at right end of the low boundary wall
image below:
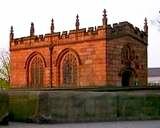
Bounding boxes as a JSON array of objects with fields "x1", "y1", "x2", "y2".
[{"x1": 118, "y1": 93, "x2": 160, "y2": 120}]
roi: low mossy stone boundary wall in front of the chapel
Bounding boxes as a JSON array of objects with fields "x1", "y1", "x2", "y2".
[{"x1": 9, "y1": 91, "x2": 160, "y2": 123}]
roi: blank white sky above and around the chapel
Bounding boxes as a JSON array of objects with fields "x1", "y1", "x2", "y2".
[{"x1": 0, "y1": 0, "x2": 160, "y2": 67}]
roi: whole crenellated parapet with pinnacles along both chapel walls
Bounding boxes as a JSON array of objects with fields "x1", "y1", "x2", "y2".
[{"x1": 10, "y1": 9, "x2": 148, "y2": 50}]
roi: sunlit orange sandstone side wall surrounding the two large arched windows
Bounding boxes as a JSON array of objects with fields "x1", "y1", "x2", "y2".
[{"x1": 10, "y1": 26, "x2": 107, "y2": 88}]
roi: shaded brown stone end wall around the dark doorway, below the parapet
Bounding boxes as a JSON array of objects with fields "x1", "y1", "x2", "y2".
[{"x1": 107, "y1": 36, "x2": 148, "y2": 86}]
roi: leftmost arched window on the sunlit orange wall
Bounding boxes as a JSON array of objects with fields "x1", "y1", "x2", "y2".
[{"x1": 30, "y1": 56, "x2": 44, "y2": 88}]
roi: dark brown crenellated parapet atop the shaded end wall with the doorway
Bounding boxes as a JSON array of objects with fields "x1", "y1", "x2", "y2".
[{"x1": 107, "y1": 21, "x2": 148, "y2": 45}]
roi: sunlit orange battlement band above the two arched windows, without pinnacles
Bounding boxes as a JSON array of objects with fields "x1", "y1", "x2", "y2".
[{"x1": 10, "y1": 26, "x2": 106, "y2": 50}]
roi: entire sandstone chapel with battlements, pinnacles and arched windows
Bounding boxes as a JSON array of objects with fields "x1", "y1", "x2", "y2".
[{"x1": 10, "y1": 9, "x2": 148, "y2": 88}]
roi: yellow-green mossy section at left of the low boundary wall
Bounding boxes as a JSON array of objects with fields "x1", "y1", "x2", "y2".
[{"x1": 9, "y1": 91, "x2": 38, "y2": 122}]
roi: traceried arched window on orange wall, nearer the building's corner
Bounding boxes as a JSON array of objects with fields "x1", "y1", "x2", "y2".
[{"x1": 61, "y1": 53, "x2": 78, "y2": 87}]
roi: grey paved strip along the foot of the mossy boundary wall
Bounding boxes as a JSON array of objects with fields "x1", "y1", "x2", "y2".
[{"x1": 0, "y1": 120, "x2": 160, "y2": 128}]
